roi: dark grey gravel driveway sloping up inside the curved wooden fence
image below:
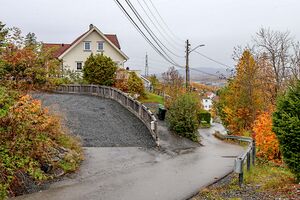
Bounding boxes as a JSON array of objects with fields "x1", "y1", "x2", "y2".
[{"x1": 33, "y1": 93, "x2": 155, "y2": 148}]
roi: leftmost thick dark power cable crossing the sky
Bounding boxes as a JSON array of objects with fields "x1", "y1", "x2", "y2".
[{"x1": 114, "y1": 0, "x2": 182, "y2": 65}]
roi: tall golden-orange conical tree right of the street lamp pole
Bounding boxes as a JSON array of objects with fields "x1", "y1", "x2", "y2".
[{"x1": 218, "y1": 50, "x2": 264, "y2": 134}]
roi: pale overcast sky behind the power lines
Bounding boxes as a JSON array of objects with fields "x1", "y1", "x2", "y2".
[{"x1": 0, "y1": 0, "x2": 300, "y2": 73}]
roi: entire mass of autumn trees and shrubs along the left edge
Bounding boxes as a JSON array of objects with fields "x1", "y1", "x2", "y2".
[{"x1": 0, "y1": 22, "x2": 83, "y2": 199}]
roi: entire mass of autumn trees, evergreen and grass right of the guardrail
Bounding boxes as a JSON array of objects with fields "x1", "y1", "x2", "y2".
[{"x1": 211, "y1": 28, "x2": 300, "y2": 199}]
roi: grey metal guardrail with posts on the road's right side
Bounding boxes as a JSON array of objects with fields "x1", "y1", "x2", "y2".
[{"x1": 215, "y1": 131, "x2": 256, "y2": 186}]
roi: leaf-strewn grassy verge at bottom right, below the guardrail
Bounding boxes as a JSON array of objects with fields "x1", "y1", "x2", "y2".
[{"x1": 192, "y1": 161, "x2": 299, "y2": 200}]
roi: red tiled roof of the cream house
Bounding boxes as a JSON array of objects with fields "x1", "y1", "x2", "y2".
[{"x1": 43, "y1": 27, "x2": 121, "y2": 58}]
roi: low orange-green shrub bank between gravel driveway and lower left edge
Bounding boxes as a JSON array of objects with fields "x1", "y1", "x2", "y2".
[{"x1": 0, "y1": 87, "x2": 83, "y2": 199}]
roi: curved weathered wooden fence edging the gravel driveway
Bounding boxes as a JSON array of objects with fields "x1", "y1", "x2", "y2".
[{"x1": 54, "y1": 84, "x2": 159, "y2": 146}]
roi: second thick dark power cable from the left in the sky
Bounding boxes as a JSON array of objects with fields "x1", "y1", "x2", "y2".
[{"x1": 125, "y1": 0, "x2": 180, "y2": 59}]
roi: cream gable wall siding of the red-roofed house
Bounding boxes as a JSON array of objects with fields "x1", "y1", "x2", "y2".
[{"x1": 62, "y1": 31, "x2": 126, "y2": 71}]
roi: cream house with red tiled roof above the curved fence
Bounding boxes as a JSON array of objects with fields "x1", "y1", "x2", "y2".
[{"x1": 43, "y1": 24, "x2": 128, "y2": 72}]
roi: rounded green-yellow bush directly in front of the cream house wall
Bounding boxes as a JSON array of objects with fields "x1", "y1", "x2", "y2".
[{"x1": 83, "y1": 54, "x2": 117, "y2": 86}]
